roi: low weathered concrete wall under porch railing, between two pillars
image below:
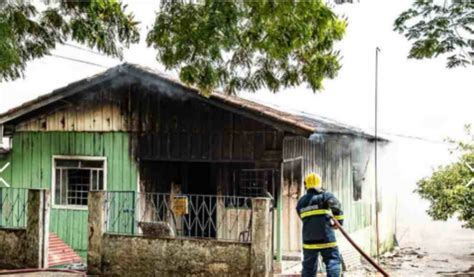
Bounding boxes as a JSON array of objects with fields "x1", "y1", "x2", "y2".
[{"x1": 102, "y1": 234, "x2": 251, "y2": 276}]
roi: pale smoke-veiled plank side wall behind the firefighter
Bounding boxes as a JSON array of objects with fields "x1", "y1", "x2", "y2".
[{"x1": 283, "y1": 135, "x2": 374, "y2": 253}]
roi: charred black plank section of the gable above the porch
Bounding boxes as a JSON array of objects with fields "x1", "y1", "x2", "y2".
[{"x1": 128, "y1": 86, "x2": 283, "y2": 162}]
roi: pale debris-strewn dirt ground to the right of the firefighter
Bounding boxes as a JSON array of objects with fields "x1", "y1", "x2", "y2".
[{"x1": 345, "y1": 220, "x2": 474, "y2": 277}]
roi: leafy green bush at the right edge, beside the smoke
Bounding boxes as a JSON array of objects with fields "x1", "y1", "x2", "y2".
[{"x1": 416, "y1": 126, "x2": 474, "y2": 229}]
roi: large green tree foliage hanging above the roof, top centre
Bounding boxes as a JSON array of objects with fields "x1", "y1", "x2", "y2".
[{"x1": 147, "y1": 0, "x2": 346, "y2": 94}]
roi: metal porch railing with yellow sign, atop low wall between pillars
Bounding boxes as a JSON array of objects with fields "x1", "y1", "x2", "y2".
[{"x1": 105, "y1": 192, "x2": 258, "y2": 242}]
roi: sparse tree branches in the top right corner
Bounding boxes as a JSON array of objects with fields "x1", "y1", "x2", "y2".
[{"x1": 394, "y1": 0, "x2": 474, "y2": 68}]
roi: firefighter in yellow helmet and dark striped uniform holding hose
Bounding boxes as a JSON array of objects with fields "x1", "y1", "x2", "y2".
[{"x1": 296, "y1": 173, "x2": 344, "y2": 277}]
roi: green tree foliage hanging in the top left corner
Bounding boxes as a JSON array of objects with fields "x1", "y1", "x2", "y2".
[{"x1": 0, "y1": 0, "x2": 139, "y2": 81}]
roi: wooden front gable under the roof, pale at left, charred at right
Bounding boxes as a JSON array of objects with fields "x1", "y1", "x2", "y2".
[{"x1": 12, "y1": 80, "x2": 284, "y2": 162}]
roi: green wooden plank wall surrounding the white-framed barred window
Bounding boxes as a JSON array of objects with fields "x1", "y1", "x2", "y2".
[{"x1": 0, "y1": 132, "x2": 138, "y2": 254}]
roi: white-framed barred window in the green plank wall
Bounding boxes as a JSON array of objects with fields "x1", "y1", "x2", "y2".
[{"x1": 54, "y1": 158, "x2": 105, "y2": 206}]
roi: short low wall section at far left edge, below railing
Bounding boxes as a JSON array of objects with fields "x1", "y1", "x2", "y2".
[{"x1": 0, "y1": 226, "x2": 26, "y2": 269}]
